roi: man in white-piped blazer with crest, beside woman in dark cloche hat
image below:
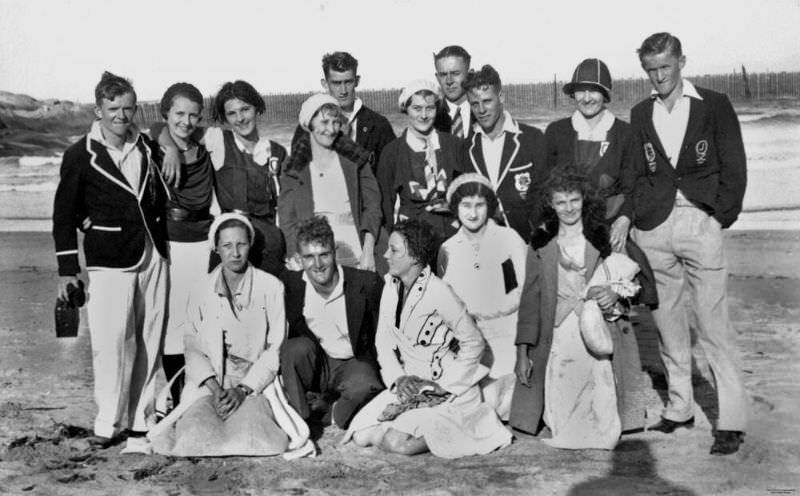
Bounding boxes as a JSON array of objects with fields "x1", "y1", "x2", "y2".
[{"x1": 462, "y1": 65, "x2": 547, "y2": 243}]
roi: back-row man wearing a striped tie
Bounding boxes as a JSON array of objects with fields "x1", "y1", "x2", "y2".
[{"x1": 433, "y1": 45, "x2": 475, "y2": 139}]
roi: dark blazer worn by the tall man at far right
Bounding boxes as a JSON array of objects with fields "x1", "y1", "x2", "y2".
[{"x1": 631, "y1": 88, "x2": 747, "y2": 231}]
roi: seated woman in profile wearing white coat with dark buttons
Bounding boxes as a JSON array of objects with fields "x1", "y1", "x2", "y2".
[{"x1": 344, "y1": 220, "x2": 511, "y2": 458}]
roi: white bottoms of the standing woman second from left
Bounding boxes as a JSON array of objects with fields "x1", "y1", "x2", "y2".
[{"x1": 164, "y1": 241, "x2": 209, "y2": 355}]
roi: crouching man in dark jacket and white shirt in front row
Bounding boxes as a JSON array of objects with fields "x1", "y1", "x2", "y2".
[{"x1": 281, "y1": 216, "x2": 384, "y2": 429}]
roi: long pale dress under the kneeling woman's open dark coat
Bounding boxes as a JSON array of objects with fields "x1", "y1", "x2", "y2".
[{"x1": 543, "y1": 237, "x2": 622, "y2": 449}]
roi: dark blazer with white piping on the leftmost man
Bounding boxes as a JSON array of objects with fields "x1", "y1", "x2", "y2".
[{"x1": 53, "y1": 134, "x2": 169, "y2": 276}]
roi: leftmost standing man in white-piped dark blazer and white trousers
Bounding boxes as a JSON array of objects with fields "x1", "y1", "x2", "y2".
[{"x1": 53, "y1": 73, "x2": 168, "y2": 453}]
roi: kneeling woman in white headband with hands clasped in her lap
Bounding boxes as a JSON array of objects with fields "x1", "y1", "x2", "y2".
[{"x1": 150, "y1": 213, "x2": 308, "y2": 456}]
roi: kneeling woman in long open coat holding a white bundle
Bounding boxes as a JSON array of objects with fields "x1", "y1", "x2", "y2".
[{"x1": 510, "y1": 168, "x2": 644, "y2": 449}]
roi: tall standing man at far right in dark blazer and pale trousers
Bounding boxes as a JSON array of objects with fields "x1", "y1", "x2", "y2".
[{"x1": 631, "y1": 33, "x2": 749, "y2": 455}]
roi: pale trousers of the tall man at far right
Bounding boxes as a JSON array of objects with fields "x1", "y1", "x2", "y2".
[{"x1": 631, "y1": 202, "x2": 749, "y2": 431}]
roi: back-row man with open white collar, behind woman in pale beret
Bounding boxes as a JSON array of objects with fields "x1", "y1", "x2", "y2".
[{"x1": 292, "y1": 52, "x2": 396, "y2": 173}]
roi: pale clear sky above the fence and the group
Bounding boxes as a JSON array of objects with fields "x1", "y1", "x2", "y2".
[{"x1": 0, "y1": 0, "x2": 800, "y2": 102}]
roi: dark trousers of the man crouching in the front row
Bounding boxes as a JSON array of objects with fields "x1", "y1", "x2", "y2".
[{"x1": 281, "y1": 337, "x2": 384, "y2": 429}]
